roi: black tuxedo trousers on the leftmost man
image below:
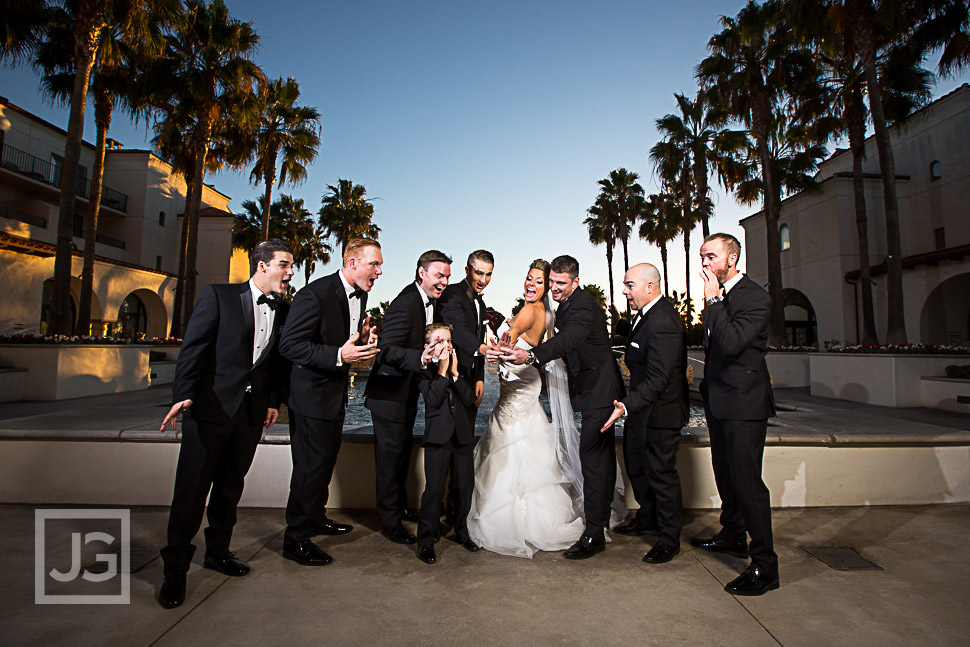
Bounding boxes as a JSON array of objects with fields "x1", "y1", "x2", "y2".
[{"x1": 161, "y1": 393, "x2": 262, "y2": 574}]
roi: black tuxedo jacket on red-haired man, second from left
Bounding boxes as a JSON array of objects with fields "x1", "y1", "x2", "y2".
[{"x1": 280, "y1": 270, "x2": 367, "y2": 420}]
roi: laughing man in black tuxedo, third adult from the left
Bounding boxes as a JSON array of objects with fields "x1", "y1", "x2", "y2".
[{"x1": 364, "y1": 249, "x2": 451, "y2": 544}]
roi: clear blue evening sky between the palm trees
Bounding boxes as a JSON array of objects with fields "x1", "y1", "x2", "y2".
[{"x1": 0, "y1": 0, "x2": 968, "y2": 314}]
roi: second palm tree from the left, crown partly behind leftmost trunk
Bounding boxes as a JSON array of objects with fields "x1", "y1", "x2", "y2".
[{"x1": 34, "y1": 5, "x2": 166, "y2": 334}]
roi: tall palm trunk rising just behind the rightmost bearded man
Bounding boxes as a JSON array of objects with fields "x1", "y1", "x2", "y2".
[{"x1": 752, "y1": 99, "x2": 789, "y2": 346}]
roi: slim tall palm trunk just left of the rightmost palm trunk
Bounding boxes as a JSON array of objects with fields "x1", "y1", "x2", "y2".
[{"x1": 845, "y1": 90, "x2": 879, "y2": 345}]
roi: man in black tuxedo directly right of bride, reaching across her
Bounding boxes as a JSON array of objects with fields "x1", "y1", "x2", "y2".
[{"x1": 496, "y1": 256, "x2": 624, "y2": 559}]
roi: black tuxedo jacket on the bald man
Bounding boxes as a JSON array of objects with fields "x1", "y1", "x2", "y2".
[{"x1": 617, "y1": 297, "x2": 688, "y2": 429}]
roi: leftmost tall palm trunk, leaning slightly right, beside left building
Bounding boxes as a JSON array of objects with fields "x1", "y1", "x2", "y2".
[{"x1": 50, "y1": 17, "x2": 101, "y2": 335}]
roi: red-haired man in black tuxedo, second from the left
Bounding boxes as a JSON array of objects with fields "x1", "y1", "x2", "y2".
[{"x1": 280, "y1": 238, "x2": 384, "y2": 566}]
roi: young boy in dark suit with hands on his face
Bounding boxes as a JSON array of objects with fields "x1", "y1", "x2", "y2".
[{"x1": 416, "y1": 323, "x2": 478, "y2": 564}]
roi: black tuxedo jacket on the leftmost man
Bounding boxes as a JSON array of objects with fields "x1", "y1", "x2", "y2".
[{"x1": 172, "y1": 281, "x2": 289, "y2": 424}]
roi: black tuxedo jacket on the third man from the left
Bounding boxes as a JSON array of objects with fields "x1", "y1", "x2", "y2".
[{"x1": 364, "y1": 283, "x2": 437, "y2": 422}]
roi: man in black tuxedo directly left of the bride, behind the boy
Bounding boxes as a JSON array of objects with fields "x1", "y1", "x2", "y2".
[{"x1": 438, "y1": 249, "x2": 495, "y2": 526}]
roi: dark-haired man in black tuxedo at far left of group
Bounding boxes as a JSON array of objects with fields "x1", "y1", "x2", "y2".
[{"x1": 158, "y1": 239, "x2": 293, "y2": 609}]
